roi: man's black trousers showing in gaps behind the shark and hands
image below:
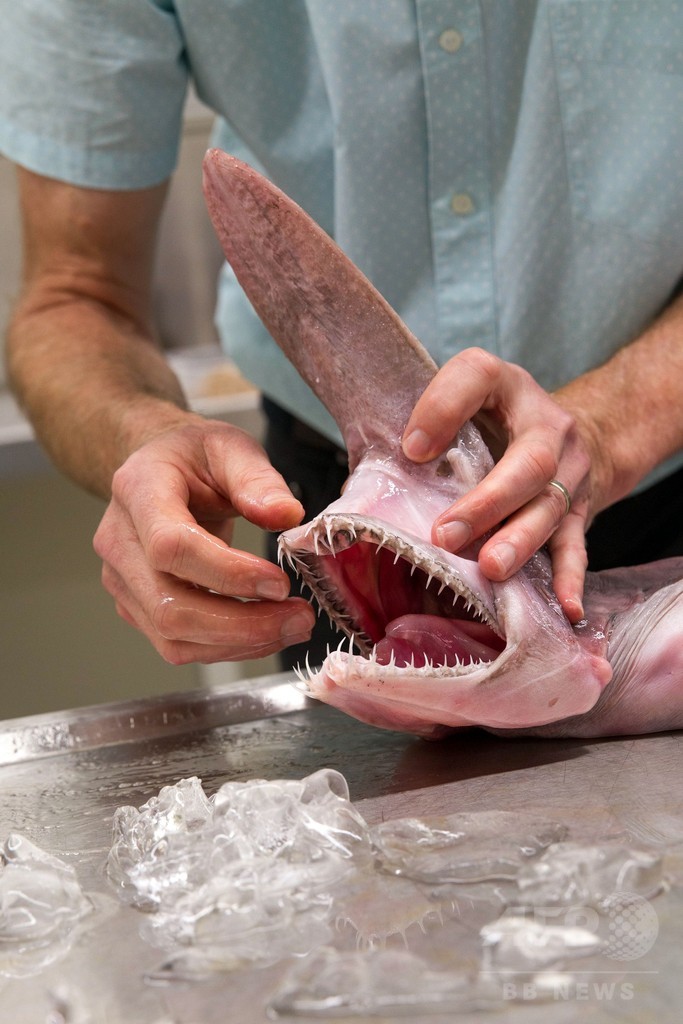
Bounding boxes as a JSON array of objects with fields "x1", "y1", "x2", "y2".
[{"x1": 263, "y1": 398, "x2": 683, "y2": 669}]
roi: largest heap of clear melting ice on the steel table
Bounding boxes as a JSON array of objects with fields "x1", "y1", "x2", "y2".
[{"x1": 108, "y1": 770, "x2": 371, "y2": 973}]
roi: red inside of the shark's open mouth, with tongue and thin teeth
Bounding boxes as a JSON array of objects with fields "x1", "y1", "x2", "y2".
[{"x1": 281, "y1": 519, "x2": 506, "y2": 671}]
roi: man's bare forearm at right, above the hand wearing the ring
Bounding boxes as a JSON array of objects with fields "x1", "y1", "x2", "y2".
[{"x1": 554, "y1": 288, "x2": 683, "y2": 515}]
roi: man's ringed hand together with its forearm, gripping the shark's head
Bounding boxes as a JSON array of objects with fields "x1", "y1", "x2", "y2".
[{"x1": 403, "y1": 307, "x2": 683, "y2": 623}]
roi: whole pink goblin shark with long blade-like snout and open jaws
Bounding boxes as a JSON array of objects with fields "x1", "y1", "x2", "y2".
[{"x1": 204, "y1": 150, "x2": 683, "y2": 737}]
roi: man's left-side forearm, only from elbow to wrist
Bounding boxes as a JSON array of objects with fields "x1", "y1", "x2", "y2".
[{"x1": 7, "y1": 293, "x2": 194, "y2": 498}]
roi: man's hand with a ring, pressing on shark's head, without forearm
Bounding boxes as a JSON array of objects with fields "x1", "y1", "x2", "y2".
[{"x1": 403, "y1": 349, "x2": 604, "y2": 623}]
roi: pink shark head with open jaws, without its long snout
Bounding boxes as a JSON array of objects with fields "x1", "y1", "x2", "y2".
[{"x1": 280, "y1": 450, "x2": 611, "y2": 736}]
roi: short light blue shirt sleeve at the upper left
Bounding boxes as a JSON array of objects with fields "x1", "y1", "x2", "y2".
[{"x1": 0, "y1": 0, "x2": 188, "y2": 188}]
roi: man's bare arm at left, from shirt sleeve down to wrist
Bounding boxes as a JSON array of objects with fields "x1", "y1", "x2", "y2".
[{"x1": 7, "y1": 168, "x2": 197, "y2": 497}]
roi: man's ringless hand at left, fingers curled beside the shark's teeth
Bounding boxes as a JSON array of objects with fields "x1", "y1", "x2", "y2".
[{"x1": 94, "y1": 417, "x2": 314, "y2": 665}]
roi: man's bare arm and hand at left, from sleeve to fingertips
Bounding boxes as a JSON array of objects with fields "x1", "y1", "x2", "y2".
[{"x1": 7, "y1": 169, "x2": 314, "y2": 664}]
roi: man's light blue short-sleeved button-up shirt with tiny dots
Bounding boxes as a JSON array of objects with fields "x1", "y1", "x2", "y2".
[{"x1": 0, "y1": 0, "x2": 683, "y2": 483}]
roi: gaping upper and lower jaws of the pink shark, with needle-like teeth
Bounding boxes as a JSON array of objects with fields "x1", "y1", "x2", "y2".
[{"x1": 280, "y1": 512, "x2": 557, "y2": 738}]
